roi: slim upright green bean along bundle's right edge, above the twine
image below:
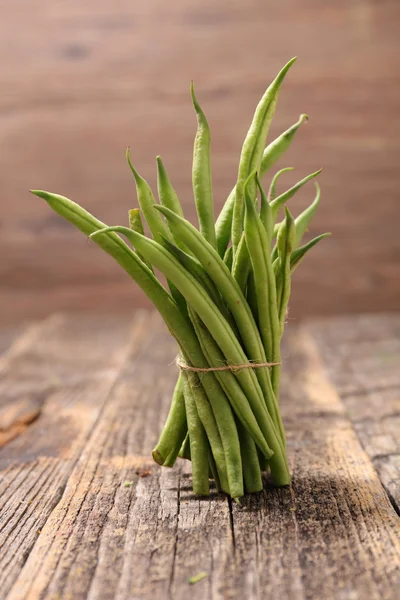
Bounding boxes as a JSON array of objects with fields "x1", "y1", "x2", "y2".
[{"x1": 276, "y1": 206, "x2": 296, "y2": 336}]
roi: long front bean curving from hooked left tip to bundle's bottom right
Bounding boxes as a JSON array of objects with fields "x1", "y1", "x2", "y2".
[{"x1": 91, "y1": 225, "x2": 290, "y2": 485}]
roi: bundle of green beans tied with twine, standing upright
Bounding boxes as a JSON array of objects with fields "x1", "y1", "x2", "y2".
[{"x1": 33, "y1": 59, "x2": 328, "y2": 500}]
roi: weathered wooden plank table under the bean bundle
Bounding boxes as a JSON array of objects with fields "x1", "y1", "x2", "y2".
[{"x1": 0, "y1": 311, "x2": 400, "y2": 600}]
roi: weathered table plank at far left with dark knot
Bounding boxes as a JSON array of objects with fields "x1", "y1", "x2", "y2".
[{"x1": 0, "y1": 314, "x2": 148, "y2": 597}]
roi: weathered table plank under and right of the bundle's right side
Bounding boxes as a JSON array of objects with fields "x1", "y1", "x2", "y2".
[{"x1": 223, "y1": 331, "x2": 400, "y2": 599}]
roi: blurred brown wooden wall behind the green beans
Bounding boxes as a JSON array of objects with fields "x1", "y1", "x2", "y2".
[{"x1": 0, "y1": 0, "x2": 400, "y2": 323}]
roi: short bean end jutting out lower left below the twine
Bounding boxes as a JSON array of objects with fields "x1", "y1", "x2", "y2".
[{"x1": 153, "y1": 374, "x2": 187, "y2": 466}]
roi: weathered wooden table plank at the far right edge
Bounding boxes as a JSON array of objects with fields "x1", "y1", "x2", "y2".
[{"x1": 309, "y1": 314, "x2": 400, "y2": 513}]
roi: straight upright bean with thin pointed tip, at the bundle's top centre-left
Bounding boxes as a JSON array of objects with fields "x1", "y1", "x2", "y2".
[{"x1": 190, "y1": 81, "x2": 217, "y2": 248}]
